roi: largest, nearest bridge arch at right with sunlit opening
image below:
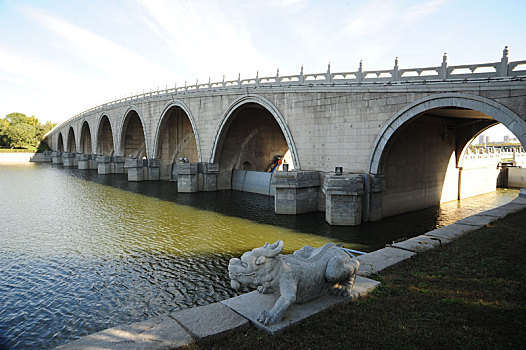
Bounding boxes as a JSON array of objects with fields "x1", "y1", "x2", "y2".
[{"x1": 369, "y1": 93, "x2": 526, "y2": 216}]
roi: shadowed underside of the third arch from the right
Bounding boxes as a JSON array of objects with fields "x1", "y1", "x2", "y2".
[{"x1": 155, "y1": 106, "x2": 199, "y2": 180}]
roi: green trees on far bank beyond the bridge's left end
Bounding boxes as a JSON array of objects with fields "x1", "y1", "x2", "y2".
[{"x1": 0, "y1": 113, "x2": 56, "y2": 149}]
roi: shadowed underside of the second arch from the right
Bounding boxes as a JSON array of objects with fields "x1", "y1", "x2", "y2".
[{"x1": 214, "y1": 103, "x2": 289, "y2": 189}]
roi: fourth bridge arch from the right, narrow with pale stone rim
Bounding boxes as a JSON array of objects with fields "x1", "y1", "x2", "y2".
[{"x1": 120, "y1": 106, "x2": 149, "y2": 158}]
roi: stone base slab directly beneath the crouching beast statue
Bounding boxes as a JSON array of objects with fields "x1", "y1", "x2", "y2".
[{"x1": 221, "y1": 276, "x2": 380, "y2": 334}]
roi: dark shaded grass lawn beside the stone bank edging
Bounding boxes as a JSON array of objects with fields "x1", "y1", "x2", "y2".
[{"x1": 191, "y1": 211, "x2": 526, "y2": 350}]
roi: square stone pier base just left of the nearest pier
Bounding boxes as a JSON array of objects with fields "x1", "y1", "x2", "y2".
[{"x1": 271, "y1": 170, "x2": 320, "y2": 215}]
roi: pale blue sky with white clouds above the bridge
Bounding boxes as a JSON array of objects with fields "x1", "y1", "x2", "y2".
[{"x1": 0, "y1": 0, "x2": 526, "y2": 127}]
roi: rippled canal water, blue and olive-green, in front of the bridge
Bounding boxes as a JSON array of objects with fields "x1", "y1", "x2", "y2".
[{"x1": 0, "y1": 162, "x2": 518, "y2": 349}]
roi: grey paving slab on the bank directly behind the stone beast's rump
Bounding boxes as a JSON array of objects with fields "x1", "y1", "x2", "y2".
[{"x1": 356, "y1": 247, "x2": 416, "y2": 276}]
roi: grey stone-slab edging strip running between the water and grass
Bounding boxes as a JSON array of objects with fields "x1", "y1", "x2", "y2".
[{"x1": 56, "y1": 189, "x2": 526, "y2": 350}]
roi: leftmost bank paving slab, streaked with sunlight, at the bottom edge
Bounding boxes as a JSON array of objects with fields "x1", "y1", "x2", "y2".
[{"x1": 57, "y1": 315, "x2": 193, "y2": 350}]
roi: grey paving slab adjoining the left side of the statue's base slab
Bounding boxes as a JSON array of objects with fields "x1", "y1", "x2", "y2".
[{"x1": 170, "y1": 303, "x2": 249, "y2": 340}]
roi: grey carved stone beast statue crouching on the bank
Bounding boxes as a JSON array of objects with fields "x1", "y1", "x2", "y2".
[{"x1": 228, "y1": 240, "x2": 360, "y2": 325}]
